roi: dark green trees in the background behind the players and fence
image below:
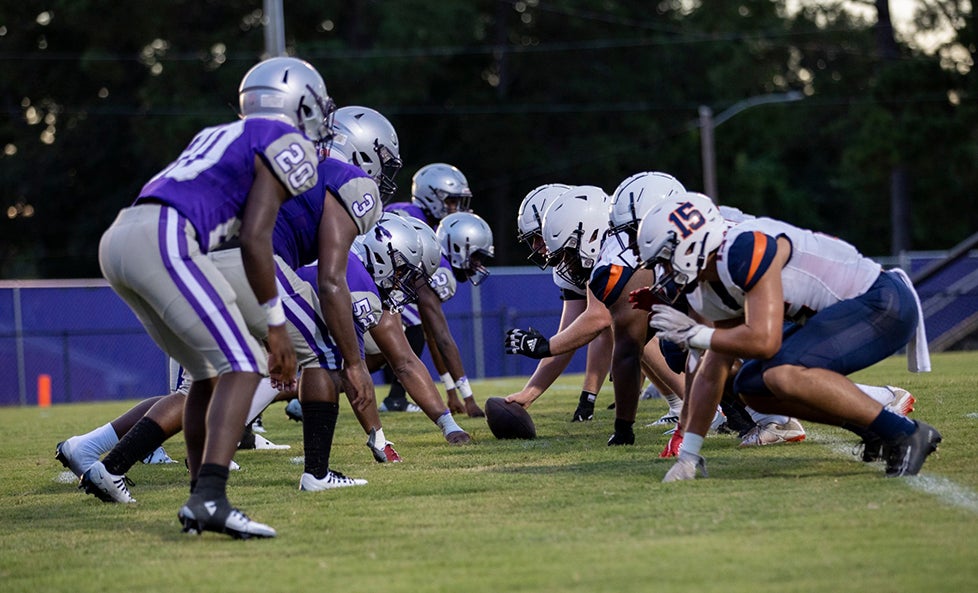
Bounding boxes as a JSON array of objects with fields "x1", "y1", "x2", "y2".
[{"x1": 0, "y1": 0, "x2": 978, "y2": 277}]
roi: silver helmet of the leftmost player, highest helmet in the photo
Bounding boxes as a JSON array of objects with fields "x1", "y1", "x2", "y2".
[{"x1": 238, "y1": 58, "x2": 336, "y2": 143}]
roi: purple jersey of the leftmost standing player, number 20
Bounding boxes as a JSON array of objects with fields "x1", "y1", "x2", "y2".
[{"x1": 136, "y1": 117, "x2": 319, "y2": 253}]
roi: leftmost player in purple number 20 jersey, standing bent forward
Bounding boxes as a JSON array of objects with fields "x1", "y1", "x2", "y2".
[{"x1": 94, "y1": 58, "x2": 334, "y2": 538}]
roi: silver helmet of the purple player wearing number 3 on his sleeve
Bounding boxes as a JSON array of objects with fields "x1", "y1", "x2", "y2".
[{"x1": 329, "y1": 106, "x2": 402, "y2": 204}]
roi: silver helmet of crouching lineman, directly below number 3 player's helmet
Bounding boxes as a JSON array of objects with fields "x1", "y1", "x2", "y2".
[{"x1": 359, "y1": 213, "x2": 425, "y2": 311}]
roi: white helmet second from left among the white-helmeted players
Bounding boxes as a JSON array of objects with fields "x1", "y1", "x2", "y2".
[{"x1": 541, "y1": 185, "x2": 608, "y2": 286}]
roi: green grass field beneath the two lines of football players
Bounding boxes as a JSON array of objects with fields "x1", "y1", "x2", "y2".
[{"x1": 0, "y1": 353, "x2": 978, "y2": 593}]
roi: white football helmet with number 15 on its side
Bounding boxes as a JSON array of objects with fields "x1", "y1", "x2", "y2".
[{"x1": 638, "y1": 192, "x2": 727, "y2": 301}]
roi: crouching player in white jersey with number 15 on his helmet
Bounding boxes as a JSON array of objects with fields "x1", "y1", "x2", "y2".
[{"x1": 638, "y1": 193, "x2": 941, "y2": 482}]
